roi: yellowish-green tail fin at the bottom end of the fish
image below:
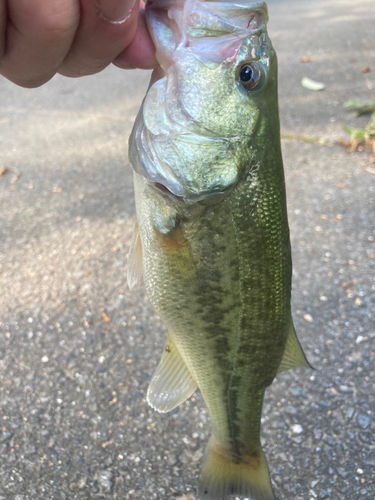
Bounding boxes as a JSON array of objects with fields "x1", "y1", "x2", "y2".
[{"x1": 199, "y1": 436, "x2": 274, "y2": 500}]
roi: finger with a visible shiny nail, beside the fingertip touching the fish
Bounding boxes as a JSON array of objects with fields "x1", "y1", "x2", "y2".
[{"x1": 59, "y1": 0, "x2": 139, "y2": 77}]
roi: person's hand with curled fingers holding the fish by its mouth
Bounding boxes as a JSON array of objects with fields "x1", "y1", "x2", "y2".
[{"x1": 0, "y1": 0, "x2": 157, "y2": 88}]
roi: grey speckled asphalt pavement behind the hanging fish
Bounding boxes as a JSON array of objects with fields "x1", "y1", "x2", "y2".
[{"x1": 0, "y1": 0, "x2": 375, "y2": 500}]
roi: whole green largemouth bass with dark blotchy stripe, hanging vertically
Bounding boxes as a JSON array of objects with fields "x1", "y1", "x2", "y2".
[{"x1": 128, "y1": 0, "x2": 310, "y2": 500}]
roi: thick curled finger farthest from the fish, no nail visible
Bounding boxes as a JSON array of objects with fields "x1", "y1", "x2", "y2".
[{"x1": 0, "y1": 0, "x2": 79, "y2": 88}]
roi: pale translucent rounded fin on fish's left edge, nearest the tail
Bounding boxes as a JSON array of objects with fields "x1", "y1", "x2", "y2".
[{"x1": 147, "y1": 333, "x2": 197, "y2": 413}]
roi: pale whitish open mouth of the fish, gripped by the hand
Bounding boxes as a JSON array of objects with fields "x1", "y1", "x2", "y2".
[{"x1": 145, "y1": 0, "x2": 268, "y2": 71}]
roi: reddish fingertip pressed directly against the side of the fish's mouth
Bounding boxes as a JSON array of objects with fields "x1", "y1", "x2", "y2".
[{"x1": 113, "y1": 8, "x2": 158, "y2": 69}]
